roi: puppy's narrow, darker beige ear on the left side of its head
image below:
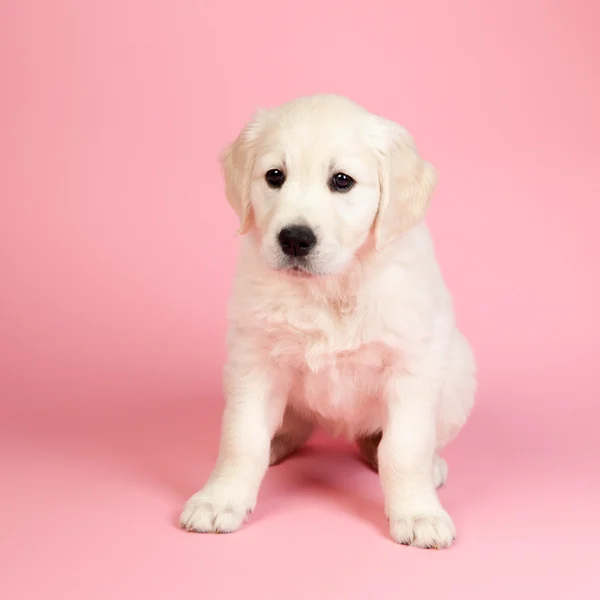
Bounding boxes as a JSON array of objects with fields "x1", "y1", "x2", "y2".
[{"x1": 221, "y1": 112, "x2": 263, "y2": 235}]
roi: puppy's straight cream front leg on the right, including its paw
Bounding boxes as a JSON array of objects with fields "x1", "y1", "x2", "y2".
[{"x1": 378, "y1": 375, "x2": 455, "y2": 548}]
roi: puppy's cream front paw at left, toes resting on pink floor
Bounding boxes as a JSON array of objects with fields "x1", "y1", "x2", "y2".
[{"x1": 179, "y1": 487, "x2": 254, "y2": 533}]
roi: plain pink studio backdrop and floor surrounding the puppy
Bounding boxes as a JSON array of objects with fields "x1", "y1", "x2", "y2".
[{"x1": 0, "y1": 0, "x2": 600, "y2": 600}]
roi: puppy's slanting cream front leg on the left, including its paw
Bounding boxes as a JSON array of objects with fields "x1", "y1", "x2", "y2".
[{"x1": 180, "y1": 365, "x2": 286, "y2": 533}]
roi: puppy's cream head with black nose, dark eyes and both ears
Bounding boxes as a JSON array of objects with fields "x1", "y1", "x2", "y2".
[{"x1": 222, "y1": 95, "x2": 437, "y2": 276}]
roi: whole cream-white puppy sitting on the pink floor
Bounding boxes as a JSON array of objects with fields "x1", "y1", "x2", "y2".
[{"x1": 181, "y1": 95, "x2": 475, "y2": 548}]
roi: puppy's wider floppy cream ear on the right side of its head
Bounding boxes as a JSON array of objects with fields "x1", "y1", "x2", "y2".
[{"x1": 375, "y1": 119, "x2": 437, "y2": 247}]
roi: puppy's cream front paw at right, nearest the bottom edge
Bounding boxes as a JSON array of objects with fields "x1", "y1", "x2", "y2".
[{"x1": 390, "y1": 510, "x2": 456, "y2": 550}]
